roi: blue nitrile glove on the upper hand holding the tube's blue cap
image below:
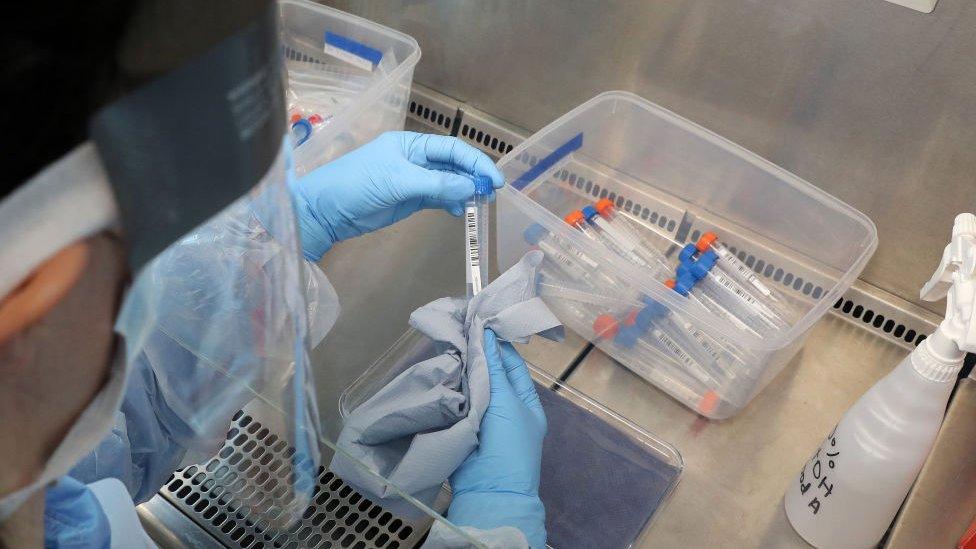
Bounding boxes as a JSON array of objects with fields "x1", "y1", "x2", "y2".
[{"x1": 292, "y1": 132, "x2": 503, "y2": 261}]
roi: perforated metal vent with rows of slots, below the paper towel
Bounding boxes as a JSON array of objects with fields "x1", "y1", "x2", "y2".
[{"x1": 160, "y1": 411, "x2": 430, "y2": 549}]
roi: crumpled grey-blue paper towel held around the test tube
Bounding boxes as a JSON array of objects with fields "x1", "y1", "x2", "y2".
[{"x1": 332, "y1": 251, "x2": 563, "y2": 516}]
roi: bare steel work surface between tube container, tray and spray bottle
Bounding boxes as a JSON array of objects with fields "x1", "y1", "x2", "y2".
[{"x1": 567, "y1": 315, "x2": 907, "y2": 547}]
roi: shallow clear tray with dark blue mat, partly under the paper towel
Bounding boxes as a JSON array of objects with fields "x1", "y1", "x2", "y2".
[{"x1": 339, "y1": 329, "x2": 684, "y2": 549}]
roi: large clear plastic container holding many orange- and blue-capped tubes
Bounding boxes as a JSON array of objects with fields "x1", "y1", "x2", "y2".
[{"x1": 495, "y1": 92, "x2": 877, "y2": 419}]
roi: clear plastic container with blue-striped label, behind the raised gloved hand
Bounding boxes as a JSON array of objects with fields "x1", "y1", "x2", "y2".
[{"x1": 278, "y1": 0, "x2": 420, "y2": 175}]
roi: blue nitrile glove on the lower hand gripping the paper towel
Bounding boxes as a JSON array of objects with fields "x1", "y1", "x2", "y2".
[{"x1": 447, "y1": 330, "x2": 546, "y2": 548}]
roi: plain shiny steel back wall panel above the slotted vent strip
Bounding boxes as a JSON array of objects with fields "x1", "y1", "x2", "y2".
[{"x1": 328, "y1": 0, "x2": 976, "y2": 314}]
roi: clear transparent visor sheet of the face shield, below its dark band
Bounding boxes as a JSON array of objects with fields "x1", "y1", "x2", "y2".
[{"x1": 117, "y1": 145, "x2": 338, "y2": 522}]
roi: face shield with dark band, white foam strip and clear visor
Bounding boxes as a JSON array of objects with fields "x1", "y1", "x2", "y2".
[{"x1": 0, "y1": 1, "x2": 328, "y2": 521}]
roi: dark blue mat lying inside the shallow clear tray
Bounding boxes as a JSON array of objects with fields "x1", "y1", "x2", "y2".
[{"x1": 536, "y1": 384, "x2": 680, "y2": 549}]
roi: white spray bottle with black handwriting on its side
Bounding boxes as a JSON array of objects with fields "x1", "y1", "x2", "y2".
[{"x1": 784, "y1": 214, "x2": 976, "y2": 549}]
